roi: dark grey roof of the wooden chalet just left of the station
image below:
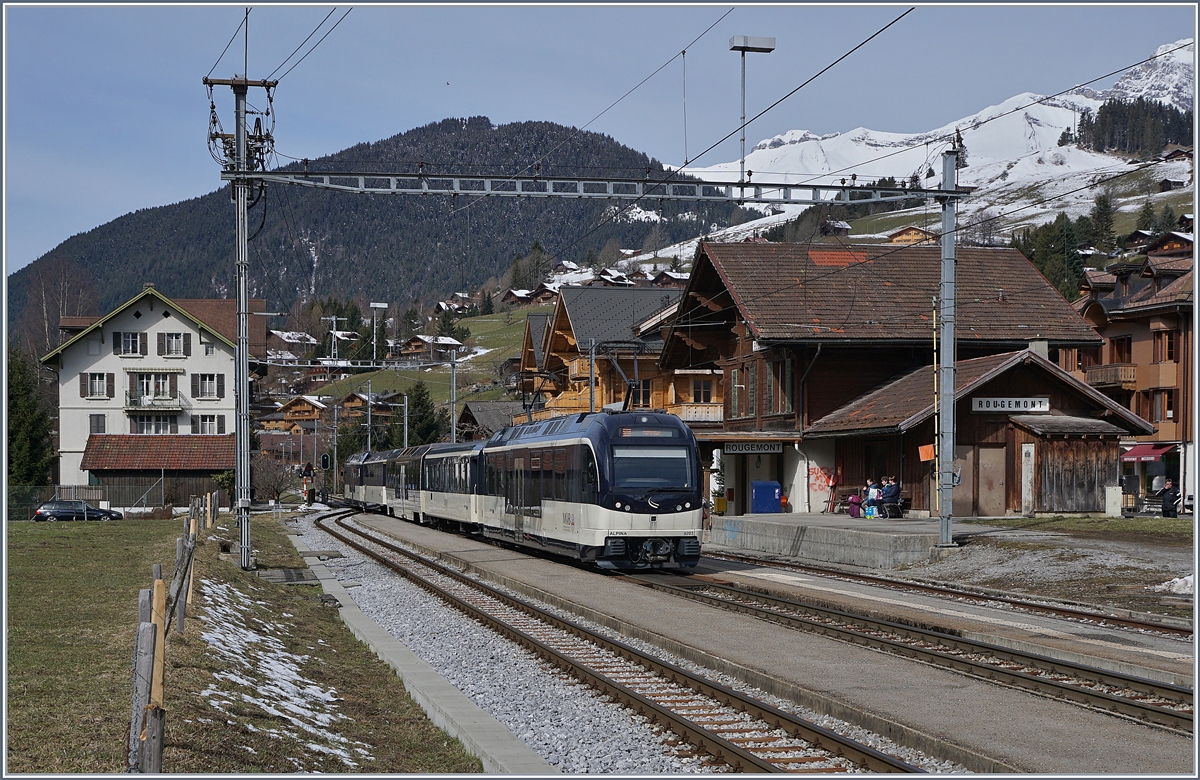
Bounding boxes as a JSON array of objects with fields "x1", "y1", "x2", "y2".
[{"x1": 559, "y1": 287, "x2": 683, "y2": 350}]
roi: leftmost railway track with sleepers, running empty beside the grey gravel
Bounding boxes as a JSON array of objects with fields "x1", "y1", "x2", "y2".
[{"x1": 316, "y1": 510, "x2": 923, "y2": 774}]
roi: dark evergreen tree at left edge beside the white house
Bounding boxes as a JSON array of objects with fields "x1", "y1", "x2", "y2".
[{"x1": 8, "y1": 343, "x2": 55, "y2": 486}]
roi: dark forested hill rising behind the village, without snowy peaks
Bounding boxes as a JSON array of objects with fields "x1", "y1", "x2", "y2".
[{"x1": 8, "y1": 116, "x2": 736, "y2": 343}]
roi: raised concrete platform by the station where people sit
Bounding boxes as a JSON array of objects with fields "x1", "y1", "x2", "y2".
[{"x1": 702, "y1": 512, "x2": 995, "y2": 569}]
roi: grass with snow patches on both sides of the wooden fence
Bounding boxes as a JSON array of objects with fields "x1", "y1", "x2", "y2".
[{"x1": 6, "y1": 515, "x2": 482, "y2": 774}]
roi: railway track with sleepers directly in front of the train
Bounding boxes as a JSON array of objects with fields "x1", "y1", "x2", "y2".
[{"x1": 626, "y1": 575, "x2": 1193, "y2": 736}]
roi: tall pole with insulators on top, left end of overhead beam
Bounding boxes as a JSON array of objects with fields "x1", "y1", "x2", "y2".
[{"x1": 203, "y1": 73, "x2": 278, "y2": 570}]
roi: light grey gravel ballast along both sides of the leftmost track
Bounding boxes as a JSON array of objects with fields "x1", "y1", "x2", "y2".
[{"x1": 296, "y1": 516, "x2": 966, "y2": 774}]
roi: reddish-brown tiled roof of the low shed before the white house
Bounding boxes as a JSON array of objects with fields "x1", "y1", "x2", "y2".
[{"x1": 79, "y1": 433, "x2": 235, "y2": 472}]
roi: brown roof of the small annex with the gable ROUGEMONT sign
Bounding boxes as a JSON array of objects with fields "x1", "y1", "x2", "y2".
[{"x1": 804, "y1": 350, "x2": 1154, "y2": 438}]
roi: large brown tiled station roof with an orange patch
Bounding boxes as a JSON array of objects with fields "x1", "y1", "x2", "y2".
[{"x1": 674, "y1": 242, "x2": 1100, "y2": 346}]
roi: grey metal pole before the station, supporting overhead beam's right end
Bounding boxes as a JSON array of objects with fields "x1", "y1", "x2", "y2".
[{"x1": 937, "y1": 145, "x2": 959, "y2": 547}]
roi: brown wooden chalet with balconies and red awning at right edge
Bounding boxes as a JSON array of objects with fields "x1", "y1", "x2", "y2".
[{"x1": 1070, "y1": 249, "x2": 1196, "y2": 504}]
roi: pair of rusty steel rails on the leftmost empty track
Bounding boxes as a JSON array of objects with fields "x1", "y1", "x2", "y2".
[{"x1": 316, "y1": 511, "x2": 923, "y2": 773}]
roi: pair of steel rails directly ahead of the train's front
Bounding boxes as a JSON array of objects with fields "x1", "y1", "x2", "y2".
[{"x1": 626, "y1": 575, "x2": 1193, "y2": 734}]
